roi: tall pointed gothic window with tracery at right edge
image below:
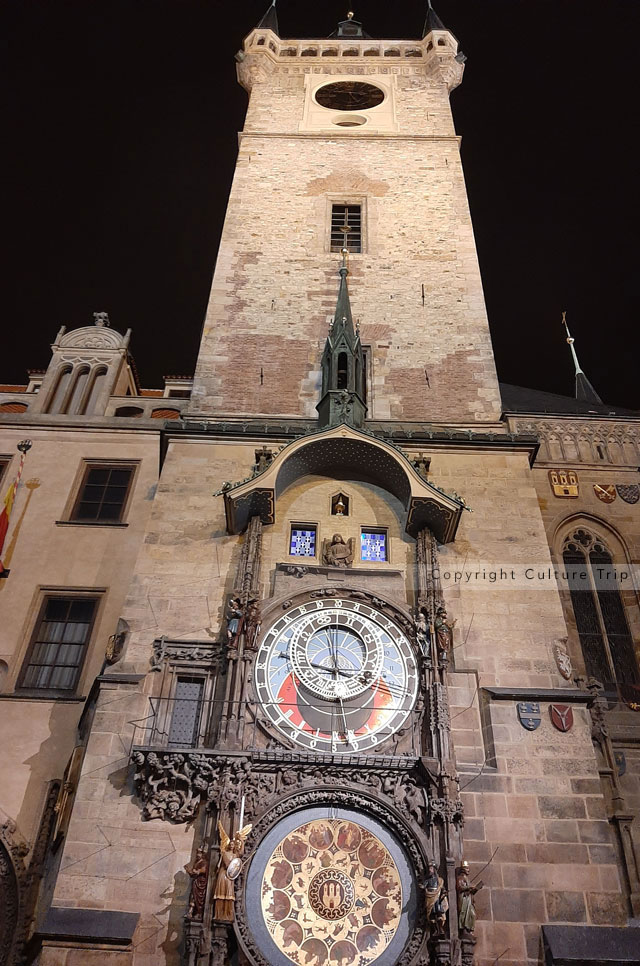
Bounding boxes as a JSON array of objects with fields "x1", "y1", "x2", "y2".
[{"x1": 562, "y1": 527, "x2": 640, "y2": 691}]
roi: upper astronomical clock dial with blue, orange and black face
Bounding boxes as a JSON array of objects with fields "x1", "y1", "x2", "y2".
[{"x1": 255, "y1": 600, "x2": 418, "y2": 754}]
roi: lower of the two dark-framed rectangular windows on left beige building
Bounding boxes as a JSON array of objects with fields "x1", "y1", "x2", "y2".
[{"x1": 19, "y1": 596, "x2": 98, "y2": 692}]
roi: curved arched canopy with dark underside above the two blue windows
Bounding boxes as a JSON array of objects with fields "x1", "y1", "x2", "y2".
[{"x1": 224, "y1": 424, "x2": 464, "y2": 543}]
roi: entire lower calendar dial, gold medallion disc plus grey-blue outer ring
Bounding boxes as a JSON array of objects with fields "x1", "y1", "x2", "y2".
[{"x1": 245, "y1": 807, "x2": 416, "y2": 966}]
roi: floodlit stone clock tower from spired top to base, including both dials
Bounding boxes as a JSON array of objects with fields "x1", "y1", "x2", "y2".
[{"x1": 35, "y1": 4, "x2": 636, "y2": 966}]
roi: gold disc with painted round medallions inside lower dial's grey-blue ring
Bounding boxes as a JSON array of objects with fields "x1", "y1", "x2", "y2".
[{"x1": 261, "y1": 818, "x2": 403, "y2": 966}]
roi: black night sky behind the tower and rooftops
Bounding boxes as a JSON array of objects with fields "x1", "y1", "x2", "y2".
[{"x1": 0, "y1": 0, "x2": 640, "y2": 408}]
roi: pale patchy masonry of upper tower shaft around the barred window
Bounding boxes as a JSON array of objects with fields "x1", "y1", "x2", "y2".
[{"x1": 192, "y1": 63, "x2": 500, "y2": 422}]
